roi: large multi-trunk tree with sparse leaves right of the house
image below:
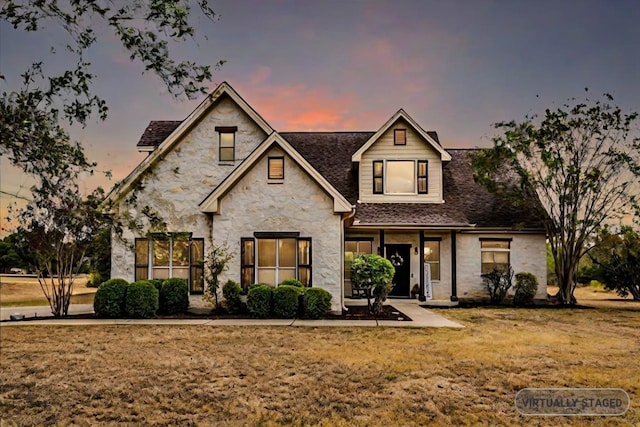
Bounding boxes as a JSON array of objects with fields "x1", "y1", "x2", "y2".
[{"x1": 474, "y1": 94, "x2": 640, "y2": 304}]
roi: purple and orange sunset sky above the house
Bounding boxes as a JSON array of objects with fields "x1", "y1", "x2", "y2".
[{"x1": 0, "y1": 0, "x2": 640, "y2": 231}]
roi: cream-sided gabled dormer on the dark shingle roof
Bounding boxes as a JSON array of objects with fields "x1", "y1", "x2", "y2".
[{"x1": 351, "y1": 109, "x2": 451, "y2": 203}]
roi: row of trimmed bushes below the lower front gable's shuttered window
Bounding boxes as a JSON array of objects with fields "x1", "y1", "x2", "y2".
[{"x1": 240, "y1": 282, "x2": 331, "y2": 319}]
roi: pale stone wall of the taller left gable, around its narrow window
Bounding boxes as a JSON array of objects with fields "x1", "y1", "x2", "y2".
[{"x1": 111, "y1": 96, "x2": 267, "y2": 281}]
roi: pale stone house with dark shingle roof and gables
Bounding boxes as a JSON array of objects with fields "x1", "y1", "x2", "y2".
[{"x1": 107, "y1": 82, "x2": 546, "y2": 311}]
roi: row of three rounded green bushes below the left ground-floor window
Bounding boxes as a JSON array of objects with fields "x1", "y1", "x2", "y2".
[{"x1": 93, "y1": 278, "x2": 189, "y2": 318}]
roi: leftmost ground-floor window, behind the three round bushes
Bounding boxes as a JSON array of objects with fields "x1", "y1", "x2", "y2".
[{"x1": 135, "y1": 235, "x2": 204, "y2": 294}]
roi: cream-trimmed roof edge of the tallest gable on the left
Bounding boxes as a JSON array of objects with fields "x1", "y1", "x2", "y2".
[{"x1": 104, "y1": 82, "x2": 274, "y2": 204}]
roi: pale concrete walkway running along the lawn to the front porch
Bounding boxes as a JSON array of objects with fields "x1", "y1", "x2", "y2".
[{"x1": 0, "y1": 300, "x2": 463, "y2": 328}]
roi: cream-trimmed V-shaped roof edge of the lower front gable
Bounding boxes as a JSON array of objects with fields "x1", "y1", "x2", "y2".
[{"x1": 200, "y1": 132, "x2": 352, "y2": 213}]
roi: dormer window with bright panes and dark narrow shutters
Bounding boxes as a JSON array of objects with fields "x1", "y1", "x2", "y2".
[{"x1": 373, "y1": 160, "x2": 428, "y2": 194}]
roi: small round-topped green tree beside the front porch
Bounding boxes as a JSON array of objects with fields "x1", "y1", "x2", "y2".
[{"x1": 351, "y1": 254, "x2": 396, "y2": 316}]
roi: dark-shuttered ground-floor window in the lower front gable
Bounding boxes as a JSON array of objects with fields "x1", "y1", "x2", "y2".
[{"x1": 240, "y1": 233, "x2": 311, "y2": 291}]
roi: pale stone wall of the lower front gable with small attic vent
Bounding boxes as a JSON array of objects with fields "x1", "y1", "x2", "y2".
[{"x1": 213, "y1": 146, "x2": 342, "y2": 312}]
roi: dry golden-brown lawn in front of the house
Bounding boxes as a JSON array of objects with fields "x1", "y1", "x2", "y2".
[{"x1": 0, "y1": 301, "x2": 640, "y2": 426}]
